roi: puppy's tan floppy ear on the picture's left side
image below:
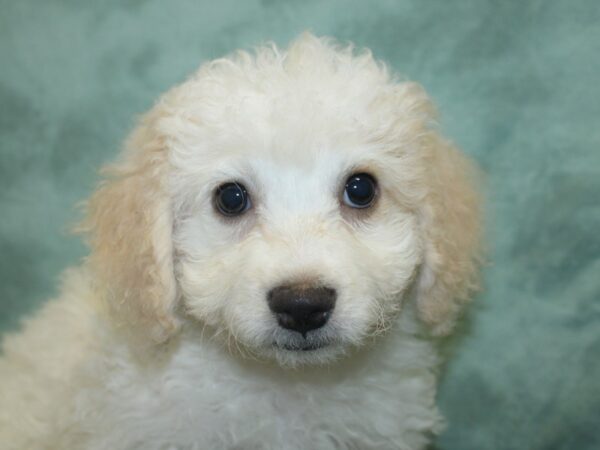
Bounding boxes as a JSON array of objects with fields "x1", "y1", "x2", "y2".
[{"x1": 80, "y1": 112, "x2": 178, "y2": 342}]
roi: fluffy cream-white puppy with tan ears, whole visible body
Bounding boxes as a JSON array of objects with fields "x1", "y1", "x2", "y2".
[{"x1": 0, "y1": 34, "x2": 480, "y2": 450}]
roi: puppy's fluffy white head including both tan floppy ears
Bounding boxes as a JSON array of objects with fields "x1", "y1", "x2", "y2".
[{"x1": 81, "y1": 35, "x2": 479, "y2": 364}]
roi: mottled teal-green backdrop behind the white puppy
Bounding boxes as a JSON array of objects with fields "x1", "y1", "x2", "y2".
[{"x1": 0, "y1": 0, "x2": 600, "y2": 450}]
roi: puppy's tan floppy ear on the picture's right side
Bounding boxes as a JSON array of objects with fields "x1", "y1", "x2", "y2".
[{"x1": 417, "y1": 132, "x2": 481, "y2": 335}]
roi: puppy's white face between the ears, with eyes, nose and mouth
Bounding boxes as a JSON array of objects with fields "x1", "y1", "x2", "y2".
[{"x1": 170, "y1": 71, "x2": 423, "y2": 364}]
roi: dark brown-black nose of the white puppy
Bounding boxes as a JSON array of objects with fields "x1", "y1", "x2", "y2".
[{"x1": 268, "y1": 285, "x2": 337, "y2": 337}]
